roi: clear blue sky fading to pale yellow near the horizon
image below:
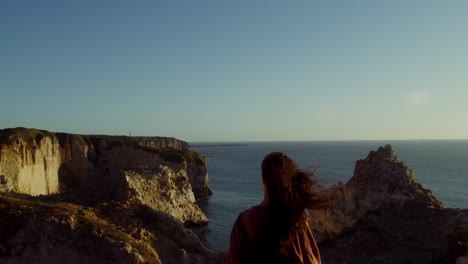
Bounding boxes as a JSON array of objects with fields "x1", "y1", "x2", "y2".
[{"x1": 0, "y1": 0, "x2": 468, "y2": 141}]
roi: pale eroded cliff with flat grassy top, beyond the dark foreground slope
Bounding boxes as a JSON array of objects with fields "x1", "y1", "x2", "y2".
[{"x1": 0, "y1": 128, "x2": 209, "y2": 224}]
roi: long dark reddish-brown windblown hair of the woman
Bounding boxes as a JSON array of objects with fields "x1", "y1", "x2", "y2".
[{"x1": 262, "y1": 152, "x2": 328, "y2": 259}]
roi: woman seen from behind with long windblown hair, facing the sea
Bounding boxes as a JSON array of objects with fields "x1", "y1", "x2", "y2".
[{"x1": 227, "y1": 152, "x2": 326, "y2": 264}]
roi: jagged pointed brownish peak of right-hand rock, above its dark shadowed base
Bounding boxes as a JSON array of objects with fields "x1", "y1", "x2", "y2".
[{"x1": 312, "y1": 145, "x2": 443, "y2": 241}]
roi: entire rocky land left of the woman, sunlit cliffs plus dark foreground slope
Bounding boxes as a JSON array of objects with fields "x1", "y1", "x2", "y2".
[{"x1": 0, "y1": 128, "x2": 222, "y2": 263}]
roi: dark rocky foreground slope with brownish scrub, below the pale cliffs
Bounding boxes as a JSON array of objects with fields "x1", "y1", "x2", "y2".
[{"x1": 0, "y1": 193, "x2": 224, "y2": 263}]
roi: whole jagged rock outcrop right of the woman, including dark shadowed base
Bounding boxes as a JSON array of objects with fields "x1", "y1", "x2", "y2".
[{"x1": 311, "y1": 145, "x2": 468, "y2": 263}]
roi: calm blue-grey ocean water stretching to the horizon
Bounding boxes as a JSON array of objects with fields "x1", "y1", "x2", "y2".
[{"x1": 191, "y1": 140, "x2": 468, "y2": 252}]
